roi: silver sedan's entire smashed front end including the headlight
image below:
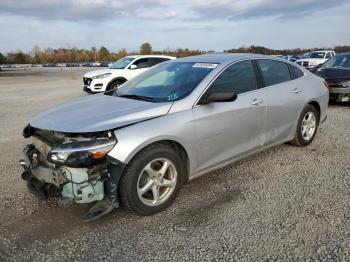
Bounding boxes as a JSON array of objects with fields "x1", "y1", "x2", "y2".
[{"x1": 20, "y1": 125, "x2": 123, "y2": 209}]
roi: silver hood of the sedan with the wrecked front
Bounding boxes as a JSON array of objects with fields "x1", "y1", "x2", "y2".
[{"x1": 30, "y1": 94, "x2": 172, "y2": 133}]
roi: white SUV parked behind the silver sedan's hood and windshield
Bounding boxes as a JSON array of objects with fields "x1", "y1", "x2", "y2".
[{"x1": 83, "y1": 55, "x2": 175, "y2": 93}]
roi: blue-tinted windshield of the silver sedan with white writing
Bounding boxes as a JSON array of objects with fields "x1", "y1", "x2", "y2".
[{"x1": 106, "y1": 62, "x2": 217, "y2": 102}]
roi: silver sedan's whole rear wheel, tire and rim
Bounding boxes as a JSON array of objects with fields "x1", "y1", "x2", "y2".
[{"x1": 290, "y1": 105, "x2": 319, "y2": 147}]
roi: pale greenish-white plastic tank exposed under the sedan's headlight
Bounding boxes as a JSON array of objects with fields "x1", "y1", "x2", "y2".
[{"x1": 62, "y1": 167, "x2": 104, "y2": 204}]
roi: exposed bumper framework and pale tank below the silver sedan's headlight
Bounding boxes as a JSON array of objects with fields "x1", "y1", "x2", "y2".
[{"x1": 20, "y1": 144, "x2": 108, "y2": 203}]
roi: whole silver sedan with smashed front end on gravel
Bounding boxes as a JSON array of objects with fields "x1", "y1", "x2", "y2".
[{"x1": 20, "y1": 54, "x2": 329, "y2": 221}]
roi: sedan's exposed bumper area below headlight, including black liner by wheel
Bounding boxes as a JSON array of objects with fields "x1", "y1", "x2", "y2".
[{"x1": 20, "y1": 136, "x2": 125, "y2": 205}]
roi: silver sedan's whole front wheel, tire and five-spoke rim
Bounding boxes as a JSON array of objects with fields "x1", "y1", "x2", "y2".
[{"x1": 119, "y1": 144, "x2": 184, "y2": 216}]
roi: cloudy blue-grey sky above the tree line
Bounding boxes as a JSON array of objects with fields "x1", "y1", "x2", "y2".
[{"x1": 0, "y1": 0, "x2": 350, "y2": 53}]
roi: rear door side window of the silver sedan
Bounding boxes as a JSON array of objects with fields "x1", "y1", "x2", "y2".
[{"x1": 257, "y1": 59, "x2": 291, "y2": 86}]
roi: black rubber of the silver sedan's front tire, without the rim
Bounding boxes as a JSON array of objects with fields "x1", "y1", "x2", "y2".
[{"x1": 118, "y1": 144, "x2": 185, "y2": 216}]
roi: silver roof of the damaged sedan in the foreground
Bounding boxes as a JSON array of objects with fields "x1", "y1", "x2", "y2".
[{"x1": 176, "y1": 53, "x2": 283, "y2": 64}]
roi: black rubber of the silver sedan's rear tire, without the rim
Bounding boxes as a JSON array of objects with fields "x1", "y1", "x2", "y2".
[{"x1": 290, "y1": 105, "x2": 320, "y2": 147}]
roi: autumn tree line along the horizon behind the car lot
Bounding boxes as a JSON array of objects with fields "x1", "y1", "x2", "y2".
[{"x1": 0, "y1": 43, "x2": 350, "y2": 64}]
